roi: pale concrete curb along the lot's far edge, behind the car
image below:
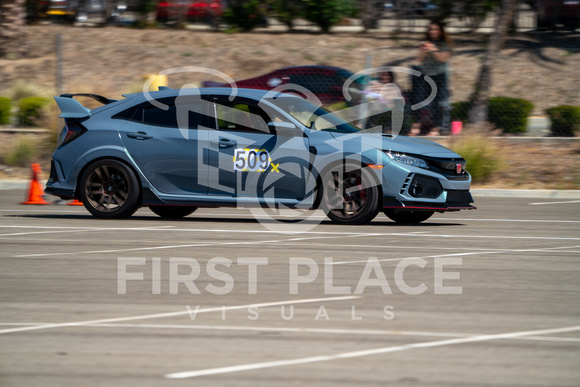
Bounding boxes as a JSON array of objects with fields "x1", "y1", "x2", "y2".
[{"x1": 0, "y1": 180, "x2": 580, "y2": 199}]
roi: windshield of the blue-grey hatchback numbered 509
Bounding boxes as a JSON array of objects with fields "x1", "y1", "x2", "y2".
[{"x1": 268, "y1": 96, "x2": 360, "y2": 133}]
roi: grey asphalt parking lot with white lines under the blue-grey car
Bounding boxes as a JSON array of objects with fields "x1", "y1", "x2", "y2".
[{"x1": 0, "y1": 189, "x2": 580, "y2": 387}]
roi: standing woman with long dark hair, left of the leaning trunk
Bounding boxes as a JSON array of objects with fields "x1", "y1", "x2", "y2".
[{"x1": 417, "y1": 21, "x2": 453, "y2": 135}]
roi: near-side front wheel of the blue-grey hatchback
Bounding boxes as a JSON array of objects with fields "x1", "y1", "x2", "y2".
[{"x1": 321, "y1": 164, "x2": 379, "y2": 224}]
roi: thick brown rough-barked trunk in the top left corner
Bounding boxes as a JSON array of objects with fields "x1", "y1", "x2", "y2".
[{"x1": 0, "y1": 0, "x2": 26, "y2": 59}]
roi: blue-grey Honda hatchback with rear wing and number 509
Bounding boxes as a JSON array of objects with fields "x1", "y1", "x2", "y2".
[{"x1": 45, "y1": 88, "x2": 475, "y2": 224}]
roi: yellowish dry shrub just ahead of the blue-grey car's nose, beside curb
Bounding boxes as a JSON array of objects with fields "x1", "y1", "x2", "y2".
[{"x1": 451, "y1": 134, "x2": 502, "y2": 183}]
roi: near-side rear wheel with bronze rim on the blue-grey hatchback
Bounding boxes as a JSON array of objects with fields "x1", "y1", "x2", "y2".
[{"x1": 79, "y1": 159, "x2": 140, "y2": 219}]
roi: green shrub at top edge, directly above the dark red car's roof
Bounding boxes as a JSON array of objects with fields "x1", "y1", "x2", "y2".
[{"x1": 304, "y1": 0, "x2": 356, "y2": 33}]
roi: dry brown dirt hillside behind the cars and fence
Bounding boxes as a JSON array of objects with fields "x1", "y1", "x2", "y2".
[{"x1": 0, "y1": 25, "x2": 580, "y2": 189}]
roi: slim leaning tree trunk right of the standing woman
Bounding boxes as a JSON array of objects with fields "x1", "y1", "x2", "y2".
[{"x1": 467, "y1": 0, "x2": 518, "y2": 124}]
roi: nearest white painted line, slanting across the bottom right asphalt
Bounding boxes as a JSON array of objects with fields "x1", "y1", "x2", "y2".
[{"x1": 165, "y1": 326, "x2": 580, "y2": 379}]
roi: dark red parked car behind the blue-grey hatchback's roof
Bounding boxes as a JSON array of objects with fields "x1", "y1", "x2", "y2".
[{"x1": 203, "y1": 66, "x2": 363, "y2": 106}]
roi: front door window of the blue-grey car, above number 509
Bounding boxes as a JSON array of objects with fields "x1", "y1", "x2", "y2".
[{"x1": 215, "y1": 100, "x2": 270, "y2": 134}]
